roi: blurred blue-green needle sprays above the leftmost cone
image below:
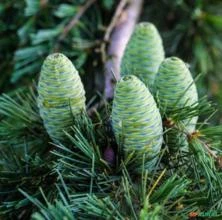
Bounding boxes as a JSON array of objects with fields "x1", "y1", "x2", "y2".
[{"x1": 11, "y1": 1, "x2": 100, "y2": 82}]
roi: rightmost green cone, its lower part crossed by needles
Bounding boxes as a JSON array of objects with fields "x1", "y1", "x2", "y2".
[{"x1": 155, "y1": 57, "x2": 198, "y2": 150}]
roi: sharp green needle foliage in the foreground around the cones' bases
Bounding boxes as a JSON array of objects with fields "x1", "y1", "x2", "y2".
[{"x1": 0, "y1": 83, "x2": 222, "y2": 220}]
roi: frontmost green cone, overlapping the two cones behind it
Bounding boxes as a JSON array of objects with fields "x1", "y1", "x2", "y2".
[{"x1": 112, "y1": 75, "x2": 163, "y2": 168}]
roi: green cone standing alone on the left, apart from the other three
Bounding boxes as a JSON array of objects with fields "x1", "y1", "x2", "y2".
[{"x1": 38, "y1": 53, "x2": 85, "y2": 141}]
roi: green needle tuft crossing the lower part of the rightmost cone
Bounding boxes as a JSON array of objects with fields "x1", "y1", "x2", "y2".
[{"x1": 158, "y1": 97, "x2": 215, "y2": 153}]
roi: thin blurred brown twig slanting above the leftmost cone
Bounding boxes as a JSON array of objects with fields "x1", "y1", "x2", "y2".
[{"x1": 55, "y1": 0, "x2": 97, "y2": 50}]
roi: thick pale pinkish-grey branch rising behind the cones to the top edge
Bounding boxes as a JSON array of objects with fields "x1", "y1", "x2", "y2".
[{"x1": 104, "y1": 0, "x2": 143, "y2": 99}]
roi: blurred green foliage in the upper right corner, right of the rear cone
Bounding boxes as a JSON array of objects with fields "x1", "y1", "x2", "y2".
[{"x1": 144, "y1": 0, "x2": 222, "y2": 74}]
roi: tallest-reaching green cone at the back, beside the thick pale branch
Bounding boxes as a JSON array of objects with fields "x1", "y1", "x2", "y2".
[{"x1": 121, "y1": 22, "x2": 164, "y2": 91}]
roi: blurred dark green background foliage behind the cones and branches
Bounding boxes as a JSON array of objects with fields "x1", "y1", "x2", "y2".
[{"x1": 0, "y1": 0, "x2": 222, "y2": 120}]
